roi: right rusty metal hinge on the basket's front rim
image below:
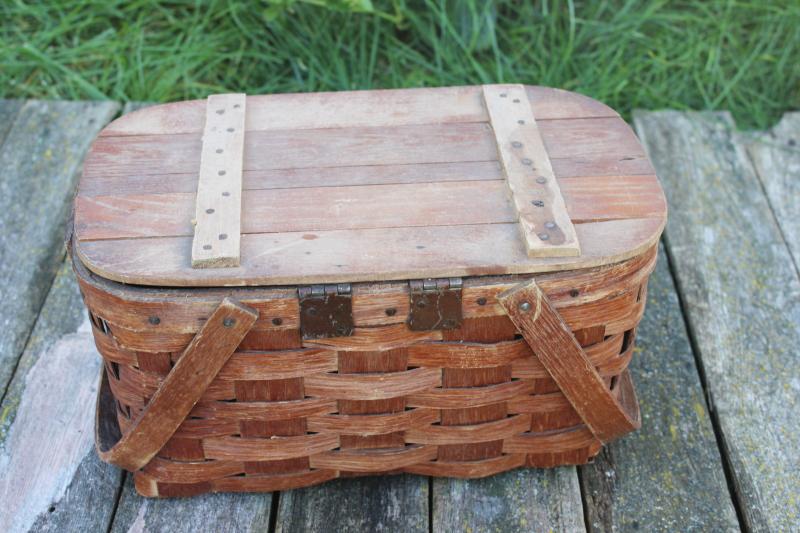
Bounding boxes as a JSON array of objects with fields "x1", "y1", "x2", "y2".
[{"x1": 408, "y1": 278, "x2": 462, "y2": 331}]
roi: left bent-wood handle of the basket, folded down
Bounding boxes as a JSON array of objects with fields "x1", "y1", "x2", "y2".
[{"x1": 95, "y1": 298, "x2": 258, "y2": 471}]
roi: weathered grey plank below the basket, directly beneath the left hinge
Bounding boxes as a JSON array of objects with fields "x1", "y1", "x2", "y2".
[{"x1": 276, "y1": 475, "x2": 429, "y2": 533}]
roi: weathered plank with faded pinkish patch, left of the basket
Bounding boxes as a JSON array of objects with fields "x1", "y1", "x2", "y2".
[{"x1": 0, "y1": 262, "x2": 122, "y2": 532}]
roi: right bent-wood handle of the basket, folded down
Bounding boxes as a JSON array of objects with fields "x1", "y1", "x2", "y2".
[{"x1": 497, "y1": 279, "x2": 641, "y2": 443}]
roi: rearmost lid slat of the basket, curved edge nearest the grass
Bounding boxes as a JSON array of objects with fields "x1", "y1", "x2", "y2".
[{"x1": 97, "y1": 87, "x2": 618, "y2": 136}]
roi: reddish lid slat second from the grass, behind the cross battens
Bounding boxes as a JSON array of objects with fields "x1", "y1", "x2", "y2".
[{"x1": 83, "y1": 118, "x2": 652, "y2": 179}]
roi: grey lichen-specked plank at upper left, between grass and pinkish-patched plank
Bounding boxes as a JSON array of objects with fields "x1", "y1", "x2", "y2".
[{"x1": 0, "y1": 101, "x2": 117, "y2": 396}]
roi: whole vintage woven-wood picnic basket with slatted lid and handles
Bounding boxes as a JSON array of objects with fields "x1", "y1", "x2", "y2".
[{"x1": 68, "y1": 85, "x2": 666, "y2": 497}]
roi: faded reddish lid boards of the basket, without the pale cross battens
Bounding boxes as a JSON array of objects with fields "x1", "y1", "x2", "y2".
[{"x1": 75, "y1": 86, "x2": 665, "y2": 286}]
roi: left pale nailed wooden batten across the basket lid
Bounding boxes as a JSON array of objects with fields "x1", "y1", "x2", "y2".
[{"x1": 192, "y1": 94, "x2": 245, "y2": 268}]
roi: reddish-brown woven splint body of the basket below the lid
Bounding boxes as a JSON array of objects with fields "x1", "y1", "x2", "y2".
[{"x1": 69, "y1": 83, "x2": 664, "y2": 497}]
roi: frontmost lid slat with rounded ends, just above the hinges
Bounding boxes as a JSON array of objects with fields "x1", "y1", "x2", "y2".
[{"x1": 77, "y1": 218, "x2": 664, "y2": 286}]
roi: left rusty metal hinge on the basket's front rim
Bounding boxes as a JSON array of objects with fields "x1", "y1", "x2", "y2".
[{"x1": 297, "y1": 283, "x2": 354, "y2": 339}]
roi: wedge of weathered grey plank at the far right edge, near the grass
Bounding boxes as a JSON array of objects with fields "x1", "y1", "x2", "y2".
[{"x1": 745, "y1": 113, "x2": 800, "y2": 268}]
